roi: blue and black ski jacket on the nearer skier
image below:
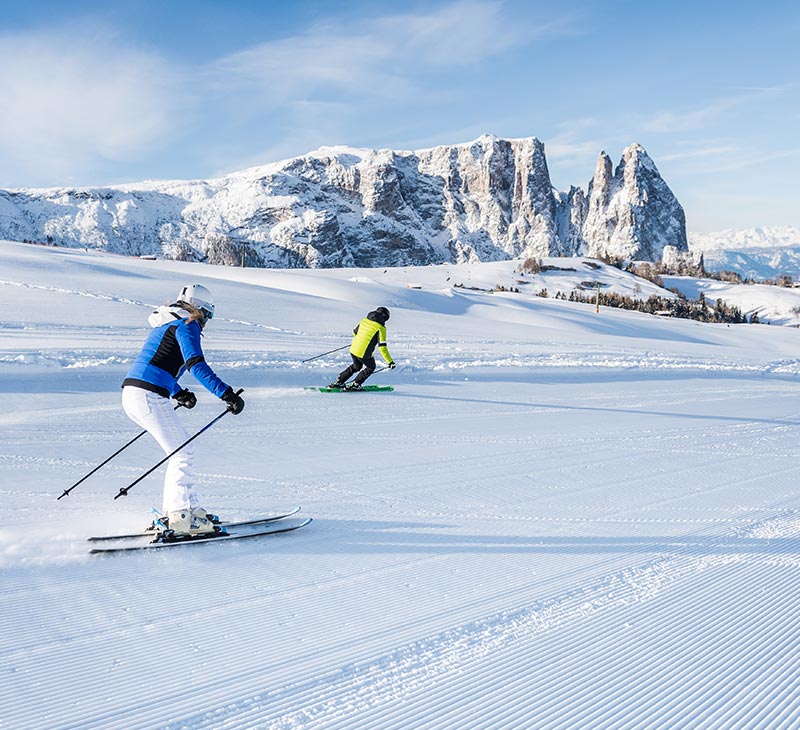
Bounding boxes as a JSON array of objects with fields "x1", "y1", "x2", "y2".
[{"x1": 122, "y1": 315, "x2": 228, "y2": 398}]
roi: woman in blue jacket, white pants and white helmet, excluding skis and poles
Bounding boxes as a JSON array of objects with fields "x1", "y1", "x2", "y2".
[{"x1": 122, "y1": 284, "x2": 244, "y2": 537}]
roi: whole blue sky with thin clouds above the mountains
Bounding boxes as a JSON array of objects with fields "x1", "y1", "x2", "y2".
[{"x1": 0, "y1": 0, "x2": 800, "y2": 231}]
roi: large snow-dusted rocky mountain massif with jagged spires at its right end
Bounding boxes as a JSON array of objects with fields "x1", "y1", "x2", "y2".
[{"x1": 0, "y1": 135, "x2": 687, "y2": 267}]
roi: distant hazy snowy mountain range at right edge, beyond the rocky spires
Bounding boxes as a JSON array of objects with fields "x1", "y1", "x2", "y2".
[{"x1": 689, "y1": 226, "x2": 800, "y2": 280}]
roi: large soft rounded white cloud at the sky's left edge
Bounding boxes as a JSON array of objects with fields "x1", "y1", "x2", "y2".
[{"x1": 0, "y1": 26, "x2": 182, "y2": 185}]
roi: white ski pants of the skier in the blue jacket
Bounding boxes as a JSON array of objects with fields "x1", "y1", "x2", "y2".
[{"x1": 122, "y1": 385, "x2": 198, "y2": 514}]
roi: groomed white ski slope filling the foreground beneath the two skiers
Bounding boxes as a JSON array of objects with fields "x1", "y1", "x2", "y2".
[{"x1": 0, "y1": 243, "x2": 800, "y2": 730}]
